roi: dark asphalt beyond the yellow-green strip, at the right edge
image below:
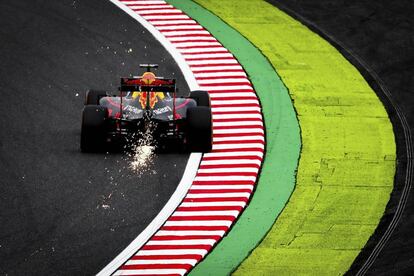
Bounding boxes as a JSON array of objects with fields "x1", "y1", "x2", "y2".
[{"x1": 269, "y1": 0, "x2": 414, "y2": 275}]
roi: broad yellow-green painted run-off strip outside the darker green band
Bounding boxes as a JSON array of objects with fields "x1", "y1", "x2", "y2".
[{"x1": 187, "y1": 0, "x2": 396, "y2": 275}]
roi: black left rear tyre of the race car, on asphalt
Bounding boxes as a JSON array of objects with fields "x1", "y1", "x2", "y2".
[{"x1": 81, "y1": 105, "x2": 108, "y2": 152}]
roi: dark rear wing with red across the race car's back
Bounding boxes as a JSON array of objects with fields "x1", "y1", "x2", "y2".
[{"x1": 119, "y1": 78, "x2": 176, "y2": 93}]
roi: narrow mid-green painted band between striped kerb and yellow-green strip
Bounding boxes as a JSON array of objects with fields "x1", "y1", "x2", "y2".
[{"x1": 167, "y1": 0, "x2": 300, "y2": 275}]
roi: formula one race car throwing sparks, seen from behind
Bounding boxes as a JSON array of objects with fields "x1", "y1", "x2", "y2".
[{"x1": 80, "y1": 64, "x2": 212, "y2": 152}]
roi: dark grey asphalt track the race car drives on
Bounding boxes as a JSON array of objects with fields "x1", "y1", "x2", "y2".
[{"x1": 0, "y1": 0, "x2": 188, "y2": 275}]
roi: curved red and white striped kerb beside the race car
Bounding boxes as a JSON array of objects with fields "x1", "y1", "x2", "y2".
[{"x1": 101, "y1": 0, "x2": 265, "y2": 275}]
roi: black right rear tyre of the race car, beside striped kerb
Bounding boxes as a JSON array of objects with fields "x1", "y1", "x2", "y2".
[{"x1": 187, "y1": 106, "x2": 213, "y2": 152}]
